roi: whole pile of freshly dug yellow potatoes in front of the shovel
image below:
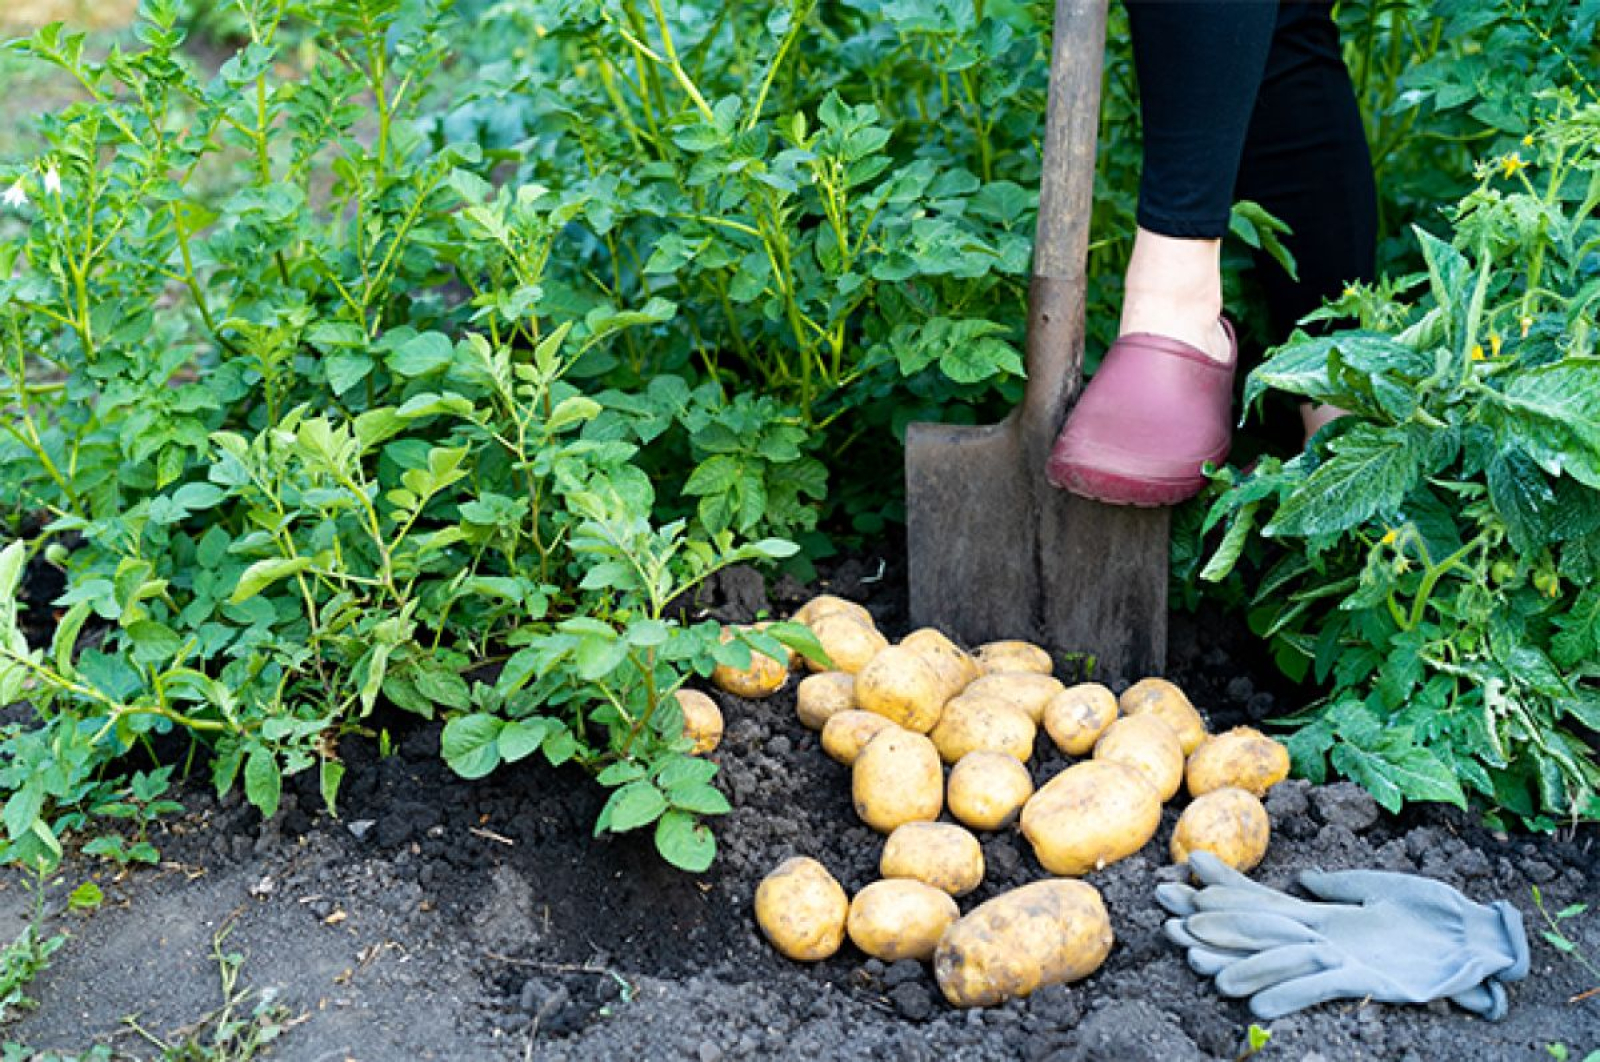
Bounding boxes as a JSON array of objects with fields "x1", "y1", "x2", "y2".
[{"x1": 715, "y1": 595, "x2": 1290, "y2": 1006}]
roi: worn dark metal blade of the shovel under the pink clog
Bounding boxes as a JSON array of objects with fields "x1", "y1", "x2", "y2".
[{"x1": 906, "y1": 414, "x2": 1168, "y2": 681}]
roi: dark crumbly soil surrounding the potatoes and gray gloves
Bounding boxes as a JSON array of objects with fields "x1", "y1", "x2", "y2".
[{"x1": 0, "y1": 558, "x2": 1600, "y2": 1062}]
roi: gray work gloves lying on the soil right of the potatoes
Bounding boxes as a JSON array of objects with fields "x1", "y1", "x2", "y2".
[{"x1": 1155, "y1": 852, "x2": 1528, "y2": 1020}]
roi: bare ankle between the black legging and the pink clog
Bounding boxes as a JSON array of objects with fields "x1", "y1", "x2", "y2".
[{"x1": 1118, "y1": 227, "x2": 1232, "y2": 363}]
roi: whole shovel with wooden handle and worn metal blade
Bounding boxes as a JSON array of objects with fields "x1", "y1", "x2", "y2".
[{"x1": 906, "y1": 0, "x2": 1168, "y2": 681}]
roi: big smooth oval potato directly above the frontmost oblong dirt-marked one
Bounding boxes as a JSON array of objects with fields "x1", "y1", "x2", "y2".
[{"x1": 1022, "y1": 760, "x2": 1162, "y2": 876}]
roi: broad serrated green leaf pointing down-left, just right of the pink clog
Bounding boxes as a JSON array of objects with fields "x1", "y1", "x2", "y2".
[{"x1": 1262, "y1": 424, "x2": 1421, "y2": 537}]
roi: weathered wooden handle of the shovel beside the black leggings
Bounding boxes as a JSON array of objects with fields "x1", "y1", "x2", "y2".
[{"x1": 1021, "y1": 0, "x2": 1107, "y2": 461}]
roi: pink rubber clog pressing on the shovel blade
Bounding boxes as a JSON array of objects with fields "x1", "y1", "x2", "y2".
[{"x1": 1046, "y1": 318, "x2": 1238, "y2": 507}]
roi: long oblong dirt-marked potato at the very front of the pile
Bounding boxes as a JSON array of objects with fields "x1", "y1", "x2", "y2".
[{"x1": 933, "y1": 878, "x2": 1114, "y2": 1006}]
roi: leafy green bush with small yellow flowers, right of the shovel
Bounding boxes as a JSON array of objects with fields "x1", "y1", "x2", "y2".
[{"x1": 1203, "y1": 91, "x2": 1600, "y2": 827}]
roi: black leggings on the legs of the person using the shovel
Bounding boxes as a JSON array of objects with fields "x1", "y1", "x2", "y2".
[{"x1": 1126, "y1": 0, "x2": 1378, "y2": 336}]
